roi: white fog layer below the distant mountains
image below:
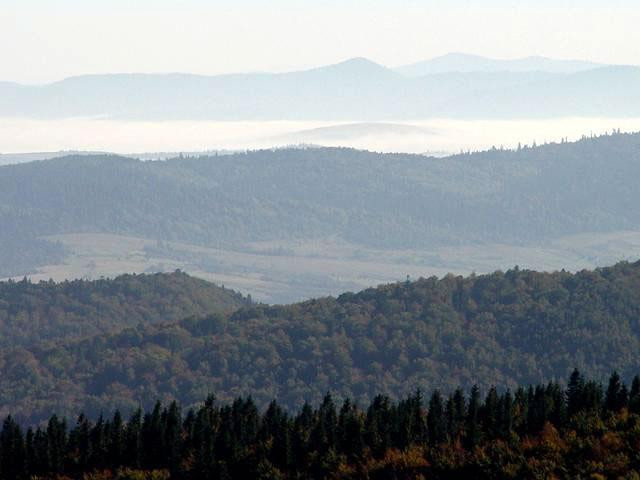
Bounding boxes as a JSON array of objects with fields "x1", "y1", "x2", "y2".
[{"x1": 0, "y1": 118, "x2": 640, "y2": 158}]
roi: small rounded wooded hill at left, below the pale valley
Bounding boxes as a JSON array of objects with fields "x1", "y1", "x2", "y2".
[{"x1": 0, "y1": 272, "x2": 249, "y2": 348}]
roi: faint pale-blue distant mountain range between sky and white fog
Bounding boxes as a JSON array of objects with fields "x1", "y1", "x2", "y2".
[{"x1": 0, "y1": 54, "x2": 640, "y2": 122}]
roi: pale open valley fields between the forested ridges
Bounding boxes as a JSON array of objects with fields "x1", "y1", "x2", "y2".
[{"x1": 15, "y1": 231, "x2": 640, "y2": 303}]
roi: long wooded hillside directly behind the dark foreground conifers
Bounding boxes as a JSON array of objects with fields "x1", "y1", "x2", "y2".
[{"x1": 5, "y1": 262, "x2": 640, "y2": 419}]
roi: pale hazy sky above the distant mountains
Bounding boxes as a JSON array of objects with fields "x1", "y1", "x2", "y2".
[{"x1": 0, "y1": 0, "x2": 640, "y2": 83}]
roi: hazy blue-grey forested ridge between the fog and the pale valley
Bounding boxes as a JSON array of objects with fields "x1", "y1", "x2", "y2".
[{"x1": 0, "y1": 129, "x2": 640, "y2": 276}]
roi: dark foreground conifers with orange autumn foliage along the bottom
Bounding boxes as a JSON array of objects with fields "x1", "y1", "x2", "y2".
[{"x1": 0, "y1": 370, "x2": 640, "y2": 479}]
